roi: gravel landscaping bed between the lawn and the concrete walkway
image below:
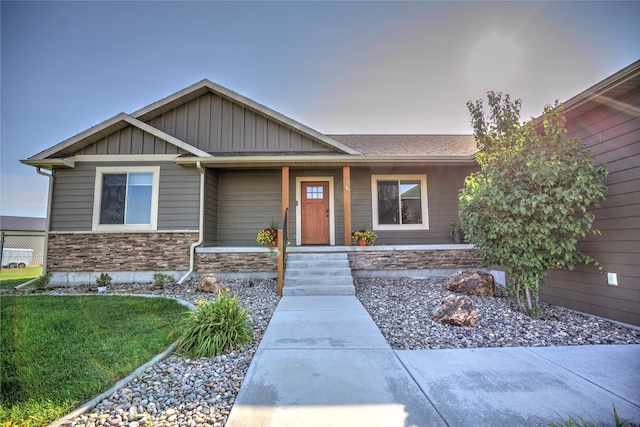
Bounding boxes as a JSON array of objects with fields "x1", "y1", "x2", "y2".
[{"x1": 41, "y1": 279, "x2": 280, "y2": 427}]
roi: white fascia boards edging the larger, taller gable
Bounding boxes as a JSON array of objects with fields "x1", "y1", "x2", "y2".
[{"x1": 131, "y1": 79, "x2": 362, "y2": 154}]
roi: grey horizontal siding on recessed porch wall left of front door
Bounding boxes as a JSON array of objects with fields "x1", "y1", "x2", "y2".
[{"x1": 217, "y1": 169, "x2": 282, "y2": 246}]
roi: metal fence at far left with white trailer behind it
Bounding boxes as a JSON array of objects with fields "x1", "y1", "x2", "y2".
[{"x1": 0, "y1": 233, "x2": 45, "y2": 281}]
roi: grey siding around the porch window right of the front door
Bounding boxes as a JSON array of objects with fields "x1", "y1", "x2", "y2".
[{"x1": 351, "y1": 167, "x2": 477, "y2": 245}]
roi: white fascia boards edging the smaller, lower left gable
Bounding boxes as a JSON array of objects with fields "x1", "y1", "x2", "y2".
[{"x1": 28, "y1": 113, "x2": 211, "y2": 161}]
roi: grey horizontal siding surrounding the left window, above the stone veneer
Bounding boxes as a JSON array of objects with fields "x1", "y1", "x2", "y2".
[{"x1": 50, "y1": 163, "x2": 200, "y2": 231}]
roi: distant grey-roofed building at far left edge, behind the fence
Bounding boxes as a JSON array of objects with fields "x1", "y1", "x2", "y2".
[{"x1": 0, "y1": 215, "x2": 46, "y2": 265}]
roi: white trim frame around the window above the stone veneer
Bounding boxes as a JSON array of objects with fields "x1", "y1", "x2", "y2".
[{"x1": 92, "y1": 166, "x2": 160, "y2": 232}]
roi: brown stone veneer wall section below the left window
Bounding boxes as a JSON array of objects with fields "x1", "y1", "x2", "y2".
[{"x1": 47, "y1": 231, "x2": 198, "y2": 273}]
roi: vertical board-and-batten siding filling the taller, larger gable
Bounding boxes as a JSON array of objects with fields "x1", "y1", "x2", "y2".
[{"x1": 148, "y1": 93, "x2": 331, "y2": 153}]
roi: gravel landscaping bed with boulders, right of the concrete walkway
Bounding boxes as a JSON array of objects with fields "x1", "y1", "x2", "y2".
[{"x1": 355, "y1": 278, "x2": 640, "y2": 350}]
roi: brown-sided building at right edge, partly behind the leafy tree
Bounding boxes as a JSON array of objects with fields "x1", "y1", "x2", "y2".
[{"x1": 541, "y1": 61, "x2": 640, "y2": 325}]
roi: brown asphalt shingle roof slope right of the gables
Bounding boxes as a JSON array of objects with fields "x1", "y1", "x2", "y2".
[{"x1": 327, "y1": 135, "x2": 478, "y2": 156}]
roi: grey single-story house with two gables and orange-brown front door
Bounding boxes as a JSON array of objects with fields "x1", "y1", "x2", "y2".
[{"x1": 18, "y1": 80, "x2": 480, "y2": 284}]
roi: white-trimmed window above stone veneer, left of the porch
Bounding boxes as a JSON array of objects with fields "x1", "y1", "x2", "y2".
[{"x1": 93, "y1": 167, "x2": 160, "y2": 230}]
